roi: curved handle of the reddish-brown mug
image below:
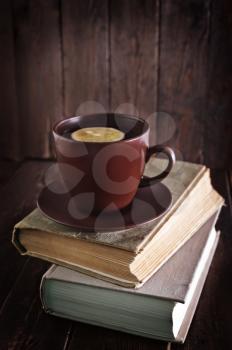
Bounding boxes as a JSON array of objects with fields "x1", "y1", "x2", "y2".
[{"x1": 139, "y1": 145, "x2": 176, "y2": 187}]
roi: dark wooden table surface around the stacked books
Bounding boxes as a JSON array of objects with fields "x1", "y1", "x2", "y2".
[{"x1": 0, "y1": 161, "x2": 232, "y2": 350}]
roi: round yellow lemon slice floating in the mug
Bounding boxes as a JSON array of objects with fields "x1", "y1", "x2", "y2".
[{"x1": 71, "y1": 127, "x2": 125, "y2": 142}]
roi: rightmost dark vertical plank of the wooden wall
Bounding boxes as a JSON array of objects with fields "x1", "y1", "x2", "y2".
[{"x1": 204, "y1": 0, "x2": 232, "y2": 168}]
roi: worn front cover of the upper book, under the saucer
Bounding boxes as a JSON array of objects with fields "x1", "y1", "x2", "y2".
[{"x1": 13, "y1": 160, "x2": 207, "y2": 252}]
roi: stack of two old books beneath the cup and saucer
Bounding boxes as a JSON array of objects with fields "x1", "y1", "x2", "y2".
[{"x1": 13, "y1": 159, "x2": 224, "y2": 342}]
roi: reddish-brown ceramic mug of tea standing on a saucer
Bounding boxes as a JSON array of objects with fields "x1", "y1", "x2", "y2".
[{"x1": 53, "y1": 113, "x2": 175, "y2": 211}]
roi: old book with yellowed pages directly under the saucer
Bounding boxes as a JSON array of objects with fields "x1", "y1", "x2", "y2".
[{"x1": 13, "y1": 160, "x2": 223, "y2": 287}]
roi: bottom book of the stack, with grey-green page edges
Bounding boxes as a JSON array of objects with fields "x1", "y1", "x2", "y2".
[{"x1": 41, "y1": 215, "x2": 218, "y2": 342}]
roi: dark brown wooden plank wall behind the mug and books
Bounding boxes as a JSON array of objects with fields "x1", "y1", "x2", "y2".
[{"x1": 0, "y1": 0, "x2": 232, "y2": 167}]
